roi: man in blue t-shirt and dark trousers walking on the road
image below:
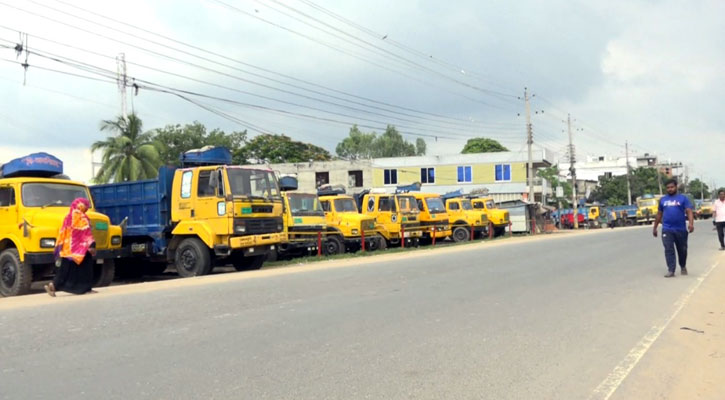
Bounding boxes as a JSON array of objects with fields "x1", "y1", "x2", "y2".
[{"x1": 652, "y1": 179, "x2": 695, "y2": 278}]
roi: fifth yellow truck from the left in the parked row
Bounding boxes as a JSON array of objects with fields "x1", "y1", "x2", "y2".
[{"x1": 356, "y1": 190, "x2": 422, "y2": 246}]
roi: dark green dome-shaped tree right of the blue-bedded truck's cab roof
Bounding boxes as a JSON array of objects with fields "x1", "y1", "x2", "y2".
[{"x1": 242, "y1": 134, "x2": 332, "y2": 163}]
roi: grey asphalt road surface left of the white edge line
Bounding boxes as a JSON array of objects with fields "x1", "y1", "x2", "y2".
[{"x1": 0, "y1": 222, "x2": 720, "y2": 399}]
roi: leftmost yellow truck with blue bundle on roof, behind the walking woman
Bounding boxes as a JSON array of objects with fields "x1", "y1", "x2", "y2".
[{"x1": 0, "y1": 153, "x2": 121, "y2": 296}]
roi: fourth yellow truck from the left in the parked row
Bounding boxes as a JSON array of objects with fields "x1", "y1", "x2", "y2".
[{"x1": 317, "y1": 185, "x2": 387, "y2": 252}]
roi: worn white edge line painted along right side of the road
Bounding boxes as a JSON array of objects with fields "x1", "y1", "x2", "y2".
[{"x1": 589, "y1": 261, "x2": 720, "y2": 400}]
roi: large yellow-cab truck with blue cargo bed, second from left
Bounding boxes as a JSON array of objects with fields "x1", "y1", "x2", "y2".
[{"x1": 91, "y1": 147, "x2": 285, "y2": 277}]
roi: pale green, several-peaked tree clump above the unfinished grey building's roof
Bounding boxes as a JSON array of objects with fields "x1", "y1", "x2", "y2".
[{"x1": 335, "y1": 125, "x2": 426, "y2": 160}]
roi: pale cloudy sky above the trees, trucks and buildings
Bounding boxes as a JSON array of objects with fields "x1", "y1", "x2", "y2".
[{"x1": 0, "y1": 0, "x2": 725, "y2": 186}]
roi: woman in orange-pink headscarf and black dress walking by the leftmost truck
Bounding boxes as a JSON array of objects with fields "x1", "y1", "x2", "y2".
[{"x1": 45, "y1": 198, "x2": 95, "y2": 297}]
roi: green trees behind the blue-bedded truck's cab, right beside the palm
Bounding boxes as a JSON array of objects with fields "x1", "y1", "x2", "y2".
[{"x1": 151, "y1": 121, "x2": 247, "y2": 165}]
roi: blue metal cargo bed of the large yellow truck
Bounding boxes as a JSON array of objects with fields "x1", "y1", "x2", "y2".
[{"x1": 91, "y1": 167, "x2": 176, "y2": 254}]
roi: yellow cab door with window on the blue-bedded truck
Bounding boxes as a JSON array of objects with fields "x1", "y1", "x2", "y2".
[{"x1": 192, "y1": 167, "x2": 230, "y2": 235}]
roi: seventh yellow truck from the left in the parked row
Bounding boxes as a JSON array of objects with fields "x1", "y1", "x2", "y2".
[{"x1": 442, "y1": 191, "x2": 488, "y2": 242}]
